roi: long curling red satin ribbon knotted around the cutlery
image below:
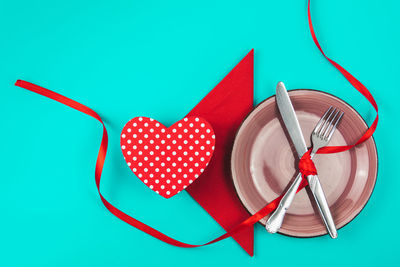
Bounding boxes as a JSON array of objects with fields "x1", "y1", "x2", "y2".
[{"x1": 15, "y1": 0, "x2": 378, "y2": 255}]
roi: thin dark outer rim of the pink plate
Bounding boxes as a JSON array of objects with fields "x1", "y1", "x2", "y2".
[{"x1": 230, "y1": 88, "x2": 379, "y2": 238}]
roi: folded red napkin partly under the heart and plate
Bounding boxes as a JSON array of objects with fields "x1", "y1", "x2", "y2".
[{"x1": 186, "y1": 50, "x2": 254, "y2": 256}]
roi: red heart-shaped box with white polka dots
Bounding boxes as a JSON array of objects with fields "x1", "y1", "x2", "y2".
[{"x1": 121, "y1": 117, "x2": 215, "y2": 198}]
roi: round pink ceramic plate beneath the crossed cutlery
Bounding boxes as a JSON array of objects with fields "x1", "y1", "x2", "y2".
[{"x1": 231, "y1": 90, "x2": 378, "y2": 237}]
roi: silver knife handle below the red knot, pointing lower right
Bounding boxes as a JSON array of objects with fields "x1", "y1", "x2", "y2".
[{"x1": 307, "y1": 175, "x2": 337, "y2": 238}]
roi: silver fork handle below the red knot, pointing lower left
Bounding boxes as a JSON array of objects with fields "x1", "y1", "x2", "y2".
[{"x1": 265, "y1": 173, "x2": 302, "y2": 234}]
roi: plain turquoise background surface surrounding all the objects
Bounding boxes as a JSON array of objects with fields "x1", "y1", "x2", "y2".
[{"x1": 0, "y1": 0, "x2": 400, "y2": 266}]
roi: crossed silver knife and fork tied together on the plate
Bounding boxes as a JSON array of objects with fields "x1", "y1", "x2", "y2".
[{"x1": 265, "y1": 82, "x2": 343, "y2": 238}]
